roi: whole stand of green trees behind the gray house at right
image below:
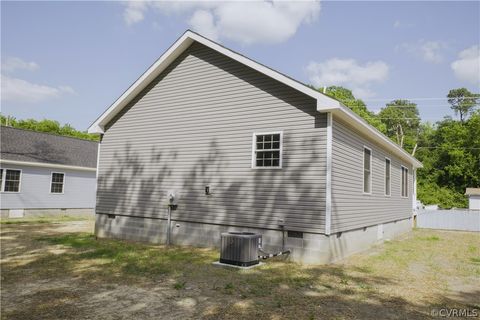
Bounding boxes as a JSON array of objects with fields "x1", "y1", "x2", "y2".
[{"x1": 320, "y1": 86, "x2": 480, "y2": 208}]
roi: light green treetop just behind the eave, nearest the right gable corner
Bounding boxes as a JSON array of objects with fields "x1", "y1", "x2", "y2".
[{"x1": 318, "y1": 86, "x2": 386, "y2": 133}]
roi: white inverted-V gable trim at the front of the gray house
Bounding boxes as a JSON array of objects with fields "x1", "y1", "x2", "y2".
[{"x1": 88, "y1": 31, "x2": 340, "y2": 134}]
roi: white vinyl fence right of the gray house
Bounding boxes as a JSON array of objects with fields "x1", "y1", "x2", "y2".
[{"x1": 417, "y1": 209, "x2": 480, "y2": 232}]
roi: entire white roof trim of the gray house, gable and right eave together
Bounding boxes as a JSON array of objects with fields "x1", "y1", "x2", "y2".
[{"x1": 88, "y1": 30, "x2": 422, "y2": 168}]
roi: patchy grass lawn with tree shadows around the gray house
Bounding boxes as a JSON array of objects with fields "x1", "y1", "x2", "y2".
[{"x1": 1, "y1": 221, "x2": 480, "y2": 319}]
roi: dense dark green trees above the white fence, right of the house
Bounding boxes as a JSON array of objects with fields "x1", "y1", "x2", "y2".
[{"x1": 417, "y1": 111, "x2": 480, "y2": 208}]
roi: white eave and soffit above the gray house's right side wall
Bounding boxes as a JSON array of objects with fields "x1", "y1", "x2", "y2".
[{"x1": 328, "y1": 105, "x2": 423, "y2": 169}]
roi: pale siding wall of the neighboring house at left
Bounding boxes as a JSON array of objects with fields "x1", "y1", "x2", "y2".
[{"x1": 0, "y1": 165, "x2": 96, "y2": 209}]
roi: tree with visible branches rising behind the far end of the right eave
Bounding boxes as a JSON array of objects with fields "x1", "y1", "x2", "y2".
[{"x1": 378, "y1": 100, "x2": 420, "y2": 154}]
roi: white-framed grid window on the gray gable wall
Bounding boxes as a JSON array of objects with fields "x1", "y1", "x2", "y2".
[{"x1": 252, "y1": 132, "x2": 282, "y2": 168}]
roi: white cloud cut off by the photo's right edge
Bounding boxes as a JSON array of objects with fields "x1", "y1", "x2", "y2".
[{"x1": 451, "y1": 45, "x2": 480, "y2": 86}]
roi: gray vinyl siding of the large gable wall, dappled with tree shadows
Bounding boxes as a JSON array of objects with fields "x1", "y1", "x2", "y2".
[{"x1": 96, "y1": 43, "x2": 326, "y2": 232}]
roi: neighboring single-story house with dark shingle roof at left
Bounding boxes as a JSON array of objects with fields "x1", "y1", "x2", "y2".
[{"x1": 0, "y1": 126, "x2": 98, "y2": 218}]
